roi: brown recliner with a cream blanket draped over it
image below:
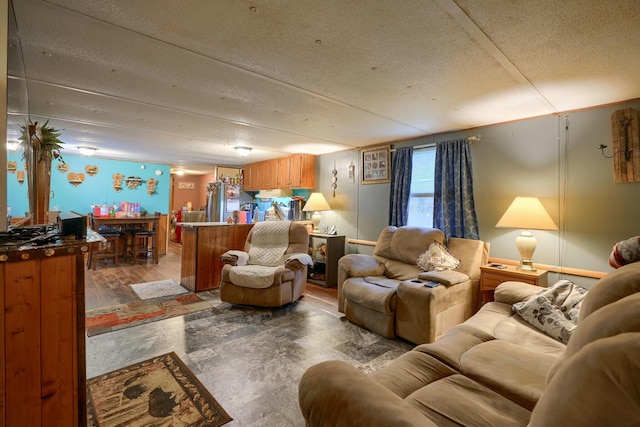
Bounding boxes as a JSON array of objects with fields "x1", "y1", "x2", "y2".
[{"x1": 220, "y1": 221, "x2": 313, "y2": 307}]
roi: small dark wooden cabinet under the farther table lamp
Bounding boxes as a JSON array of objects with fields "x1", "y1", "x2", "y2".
[{"x1": 307, "y1": 234, "x2": 344, "y2": 288}]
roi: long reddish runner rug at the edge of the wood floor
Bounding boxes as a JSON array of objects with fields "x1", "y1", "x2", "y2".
[{"x1": 85, "y1": 294, "x2": 213, "y2": 337}]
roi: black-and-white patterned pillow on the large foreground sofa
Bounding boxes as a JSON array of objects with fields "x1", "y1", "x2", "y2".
[{"x1": 513, "y1": 280, "x2": 587, "y2": 344}]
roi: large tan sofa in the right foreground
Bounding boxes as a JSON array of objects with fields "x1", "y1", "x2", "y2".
[{"x1": 299, "y1": 262, "x2": 640, "y2": 427}]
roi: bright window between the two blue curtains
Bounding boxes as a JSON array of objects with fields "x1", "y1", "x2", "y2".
[{"x1": 407, "y1": 147, "x2": 436, "y2": 227}]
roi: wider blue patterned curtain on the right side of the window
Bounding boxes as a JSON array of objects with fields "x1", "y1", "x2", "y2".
[{"x1": 433, "y1": 138, "x2": 480, "y2": 239}]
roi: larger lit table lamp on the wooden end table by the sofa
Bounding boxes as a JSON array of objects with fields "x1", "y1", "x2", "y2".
[{"x1": 496, "y1": 197, "x2": 558, "y2": 271}]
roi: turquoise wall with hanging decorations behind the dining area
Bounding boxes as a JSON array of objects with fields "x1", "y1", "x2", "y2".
[{"x1": 7, "y1": 153, "x2": 171, "y2": 217}]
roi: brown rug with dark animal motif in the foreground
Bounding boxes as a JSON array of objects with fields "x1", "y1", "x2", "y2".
[{"x1": 87, "y1": 352, "x2": 232, "y2": 427}]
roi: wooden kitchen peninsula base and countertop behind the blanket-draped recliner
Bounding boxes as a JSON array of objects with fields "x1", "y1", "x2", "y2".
[{"x1": 178, "y1": 222, "x2": 253, "y2": 292}]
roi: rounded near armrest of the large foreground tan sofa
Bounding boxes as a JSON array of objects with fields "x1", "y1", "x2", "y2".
[{"x1": 298, "y1": 360, "x2": 436, "y2": 427}]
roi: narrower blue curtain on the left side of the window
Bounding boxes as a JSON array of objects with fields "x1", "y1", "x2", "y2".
[{"x1": 389, "y1": 147, "x2": 413, "y2": 227}]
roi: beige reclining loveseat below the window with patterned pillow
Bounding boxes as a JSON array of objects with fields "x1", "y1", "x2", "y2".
[{"x1": 338, "y1": 226, "x2": 489, "y2": 344}]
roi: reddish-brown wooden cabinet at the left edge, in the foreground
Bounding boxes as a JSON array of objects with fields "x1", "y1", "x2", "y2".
[{"x1": 0, "y1": 242, "x2": 97, "y2": 426}]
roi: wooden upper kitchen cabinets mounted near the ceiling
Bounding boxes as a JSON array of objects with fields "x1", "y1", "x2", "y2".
[{"x1": 244, "y1": 154, "x2": 316, "y2": 191}]
